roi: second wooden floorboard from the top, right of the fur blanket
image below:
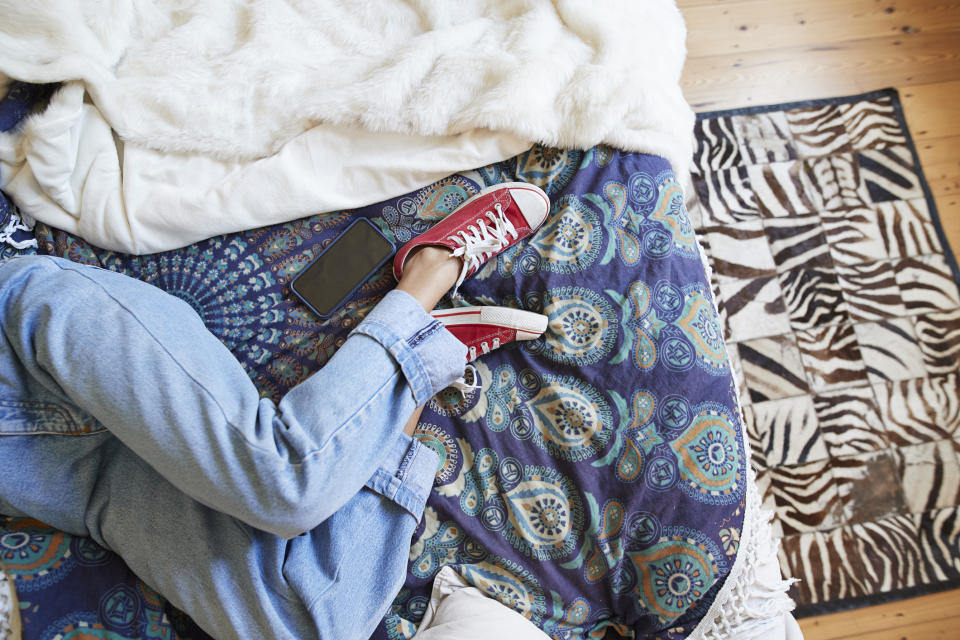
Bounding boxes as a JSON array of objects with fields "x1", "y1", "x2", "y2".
[{"x1": 680, "y1": 32, "x2": 960, "y2": 111}]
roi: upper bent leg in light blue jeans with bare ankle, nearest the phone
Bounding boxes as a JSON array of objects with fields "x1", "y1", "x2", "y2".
[{"x1": 0, "y1": 251, "x2": 465, "y2": 537}]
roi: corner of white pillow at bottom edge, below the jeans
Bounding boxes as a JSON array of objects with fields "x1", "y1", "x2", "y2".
[{"x1": 413, "y1": 567, "x2": 550, "y2": 640}]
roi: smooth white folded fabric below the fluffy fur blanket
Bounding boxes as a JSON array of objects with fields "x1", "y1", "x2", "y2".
[{"x1": 0, "y1": 82, "x2": 530, "y2": 254}]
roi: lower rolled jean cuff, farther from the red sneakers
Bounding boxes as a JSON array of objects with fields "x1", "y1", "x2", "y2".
[{"x1": 366, "y1": 433, "x2": 440, "y2": 520}]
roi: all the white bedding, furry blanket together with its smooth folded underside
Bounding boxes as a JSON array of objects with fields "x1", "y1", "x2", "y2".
[{"x1": 0, "y1": 0, "x2": 693, "y2": 253}]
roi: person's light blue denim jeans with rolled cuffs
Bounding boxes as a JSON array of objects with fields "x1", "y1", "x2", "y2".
[{"x1": 0, "y1": 256, "x2": 465, "y2": 640}]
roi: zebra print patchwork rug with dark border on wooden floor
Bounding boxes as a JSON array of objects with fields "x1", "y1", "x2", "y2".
[{"x1": 689, "y1": 90, "x2": 960, "y2": 615}]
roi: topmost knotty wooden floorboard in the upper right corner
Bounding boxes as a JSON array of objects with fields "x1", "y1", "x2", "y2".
[{"x1": 683, "y1": 0, "x2": 960, "y2": 57}]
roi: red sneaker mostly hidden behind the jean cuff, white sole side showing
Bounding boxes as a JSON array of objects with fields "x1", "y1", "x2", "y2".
[{"x1": 430, "y1": 307, "x2": 547, "y2": 362}]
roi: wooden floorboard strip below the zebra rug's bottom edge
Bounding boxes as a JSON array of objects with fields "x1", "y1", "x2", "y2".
[{"x1": 799, "y1": 590, "x2": 960, "y2": 640}]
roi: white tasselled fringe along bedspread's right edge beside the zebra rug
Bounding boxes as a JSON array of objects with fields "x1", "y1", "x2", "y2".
[{"x1": 687, "y1": 228, "x2": 797, "y2": 640}]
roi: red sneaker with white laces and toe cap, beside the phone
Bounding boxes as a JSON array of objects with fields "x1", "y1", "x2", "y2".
[{"x1": 393, "y1": 182, "x2": 550, "y2": 291}]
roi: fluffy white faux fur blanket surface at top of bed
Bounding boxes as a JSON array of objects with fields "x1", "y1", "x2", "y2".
[{"x1": 0, "y1": 0, "x2": 692, "y2": 169}]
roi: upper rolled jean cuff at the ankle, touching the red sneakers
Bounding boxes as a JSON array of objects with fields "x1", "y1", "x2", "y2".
[{"x1": 353, "y1": 289, "x2": 467, "y2": 407}]
